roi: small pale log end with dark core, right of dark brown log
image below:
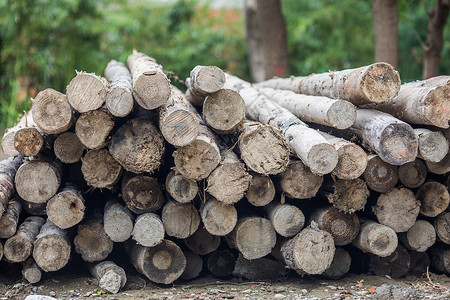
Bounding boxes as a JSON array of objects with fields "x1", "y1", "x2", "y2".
[{"x1": 165, "y1": 171, "x2": 198, "y2": 203}]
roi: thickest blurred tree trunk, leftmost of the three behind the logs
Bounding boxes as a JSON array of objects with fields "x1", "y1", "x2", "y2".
[{"x1": 245, "y1": 0, "x2": 290, "y2": 82}]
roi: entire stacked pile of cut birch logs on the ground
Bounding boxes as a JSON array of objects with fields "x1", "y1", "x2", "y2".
[{"x1": 0, "y1": 52, "x2": 450, "y2": 293}]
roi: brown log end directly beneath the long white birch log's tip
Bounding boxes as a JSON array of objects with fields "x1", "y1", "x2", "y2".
[{"x1": 279, "y1": 160, "x2": 323, "y2": 199}]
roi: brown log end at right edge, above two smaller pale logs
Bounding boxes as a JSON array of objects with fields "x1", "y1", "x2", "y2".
[{"x1": 416, "y1": 181, "x2": 450, "y2": 217}]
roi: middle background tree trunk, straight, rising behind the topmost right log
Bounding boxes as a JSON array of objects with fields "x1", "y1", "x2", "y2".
[{"x1": 372, "y1": 0, "x2": 398, "y2": 68}]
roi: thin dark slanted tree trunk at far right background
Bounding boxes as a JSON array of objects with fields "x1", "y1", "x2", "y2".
[{"x1": 422, "y1": 0, "x2": 450, "y2": 79}]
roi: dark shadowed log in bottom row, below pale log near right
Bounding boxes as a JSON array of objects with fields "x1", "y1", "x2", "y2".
[{"x1": 369, "y1": 245, "x2": 411, "y2": 278}]
